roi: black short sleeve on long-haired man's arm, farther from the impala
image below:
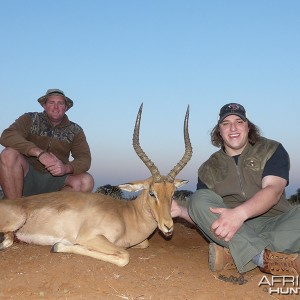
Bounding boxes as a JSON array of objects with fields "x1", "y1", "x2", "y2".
[{"x1": 262, "y1": 144, "x2": 290, "y2": 185}]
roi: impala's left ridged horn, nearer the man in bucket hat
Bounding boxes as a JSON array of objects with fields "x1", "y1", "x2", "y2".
[{"x1": 132, "y1": 103, "x2": 161, "y2": 182}]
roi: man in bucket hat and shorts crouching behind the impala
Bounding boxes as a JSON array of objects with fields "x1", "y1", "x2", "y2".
[{"x1": 0, "y1": 89, "x2": 94, "y2": 199}]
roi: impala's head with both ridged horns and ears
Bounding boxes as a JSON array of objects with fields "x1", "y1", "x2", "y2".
[{"x1": 120, "y1": 104, "x2": 192, "y2": 236}]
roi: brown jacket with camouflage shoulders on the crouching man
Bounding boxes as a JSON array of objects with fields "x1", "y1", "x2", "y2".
[{"x1": 0, "y1": 112, "x2": 91, "y2": 174}]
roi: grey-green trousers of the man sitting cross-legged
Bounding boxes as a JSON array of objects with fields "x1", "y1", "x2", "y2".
[{"x1": 188, "y1": 189, "x2": 300, "y2": 273}]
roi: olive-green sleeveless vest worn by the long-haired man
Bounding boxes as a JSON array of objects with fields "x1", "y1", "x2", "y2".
[{"x1": 198, "y1": 138, "x2": 291, "y2": 216}]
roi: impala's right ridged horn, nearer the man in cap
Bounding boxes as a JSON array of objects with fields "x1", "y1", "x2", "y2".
[{"x1": 167, "y1": 105, "x2": 193, "y2": 182}]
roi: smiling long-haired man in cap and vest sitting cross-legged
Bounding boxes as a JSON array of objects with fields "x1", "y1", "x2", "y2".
[{"x1": 172, "y1": 103, "x2": 300, "y2": 276}]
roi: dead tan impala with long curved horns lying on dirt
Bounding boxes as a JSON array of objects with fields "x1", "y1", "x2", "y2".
[{"x1": 0, "y1": 104, "x2": 192, "y2": 267}]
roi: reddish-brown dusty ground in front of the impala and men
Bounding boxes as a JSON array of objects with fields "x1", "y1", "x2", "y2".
[{"x1": 0, "y1": 219, "x2": 300, "y2": 300}]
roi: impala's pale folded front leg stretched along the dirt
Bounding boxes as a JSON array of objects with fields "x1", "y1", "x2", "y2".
[{"x1": 51, "y1": 236, "x2": 129, "y2": 267}]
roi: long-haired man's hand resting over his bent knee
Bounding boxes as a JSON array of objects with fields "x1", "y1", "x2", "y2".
[{"x1": 210, "y1": 207, "x2": 245, "y2": 242}]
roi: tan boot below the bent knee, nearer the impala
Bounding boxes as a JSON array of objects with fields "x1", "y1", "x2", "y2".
[{"x1": 208, "y1": 243, "x2": 236, "y2": 272}]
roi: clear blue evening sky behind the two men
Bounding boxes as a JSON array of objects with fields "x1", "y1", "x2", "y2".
[{"x1": 0, "y1": 0, "x2": 300, "y2": 195}]
